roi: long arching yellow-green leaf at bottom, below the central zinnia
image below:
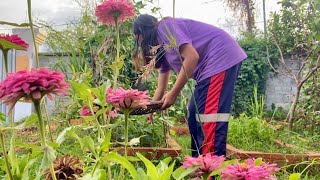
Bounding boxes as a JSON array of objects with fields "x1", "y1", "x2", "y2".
[{"x1": 104, "y1": 152, "x2": 138, "y2": 179}]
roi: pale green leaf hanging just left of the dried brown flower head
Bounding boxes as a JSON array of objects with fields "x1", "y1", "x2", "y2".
[{"x1": 36, "y1": 146, "x2": 56, "y2": 179}]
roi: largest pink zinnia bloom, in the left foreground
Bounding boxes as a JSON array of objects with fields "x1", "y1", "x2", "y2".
[{"x1": 0, "y1": 68, "x2": 69, "y2": 108}]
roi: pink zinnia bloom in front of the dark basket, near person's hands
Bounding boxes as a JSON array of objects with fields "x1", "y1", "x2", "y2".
[{"x1": 107, "y1": 88, "x2": 150, "y2": 110}]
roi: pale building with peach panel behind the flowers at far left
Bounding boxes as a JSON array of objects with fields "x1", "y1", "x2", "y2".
[{"x1": 0, "y1": 28, "x2": 46, "y2": 121}]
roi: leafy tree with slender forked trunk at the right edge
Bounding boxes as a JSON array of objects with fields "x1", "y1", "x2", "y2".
[{"x1": 269, "y1": 0, "x2": 320, "y2": 130}]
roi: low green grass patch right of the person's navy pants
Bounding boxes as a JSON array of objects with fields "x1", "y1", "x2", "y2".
[{"x1": 228, "y1": 115, "x2": 319, "y2": 154}]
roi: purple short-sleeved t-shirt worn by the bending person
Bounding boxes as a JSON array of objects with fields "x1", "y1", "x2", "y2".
[{"x1": 158, "y1": 18, "x2": 247, "y2": 82}]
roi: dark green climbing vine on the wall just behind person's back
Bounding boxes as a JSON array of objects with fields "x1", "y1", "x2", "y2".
[{"x1": 232, "y1": 34, "x2": 276, "y2": 116}]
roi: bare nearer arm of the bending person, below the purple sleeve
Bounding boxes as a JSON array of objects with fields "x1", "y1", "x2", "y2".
[{"x1": 162, "y1": 44, "x2": 199, "y2": 109}]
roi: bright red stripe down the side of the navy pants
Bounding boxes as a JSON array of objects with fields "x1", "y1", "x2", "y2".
[{"x1": 202, "y1": 71, "x2": 225, "y2": 154}]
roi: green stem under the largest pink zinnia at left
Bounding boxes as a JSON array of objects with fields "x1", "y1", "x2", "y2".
[{"x1": 33, "y1": 100, "x2": 57, "y2": 180}]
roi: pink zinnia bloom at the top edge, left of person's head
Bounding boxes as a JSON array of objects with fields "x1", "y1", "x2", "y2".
[{"x1": 95, "y1": 0, "x2": 135, "y2": 26}]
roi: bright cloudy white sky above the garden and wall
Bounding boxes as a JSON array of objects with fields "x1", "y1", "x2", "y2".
[{"x1": 0, "y1": 0, "x2": 278, "y2": 34}]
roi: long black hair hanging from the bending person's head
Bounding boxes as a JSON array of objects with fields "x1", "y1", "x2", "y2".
[{"x1": 133, "y1": 14, "x2": 164, "y2": 68}]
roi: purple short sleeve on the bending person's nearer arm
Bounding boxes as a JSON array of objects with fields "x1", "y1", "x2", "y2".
[{"x1": 158, "y1": 18, "x2": 192, "y2": 48}]
